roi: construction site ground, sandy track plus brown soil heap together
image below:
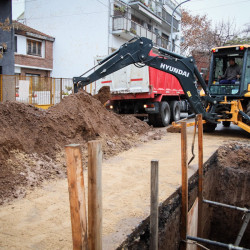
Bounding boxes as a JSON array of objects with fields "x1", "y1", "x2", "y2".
[{"x1": 0, "y1": 93, "x2": 249, "y2": 249}]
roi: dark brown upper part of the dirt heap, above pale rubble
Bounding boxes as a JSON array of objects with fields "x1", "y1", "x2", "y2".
[{"x1": 0, "y1": 92, "x2": 149, "y2": 160}]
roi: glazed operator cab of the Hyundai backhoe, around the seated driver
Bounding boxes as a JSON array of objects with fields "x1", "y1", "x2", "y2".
[{"x1": 208, "y1": 45, "x2": 250, "y2": 99}]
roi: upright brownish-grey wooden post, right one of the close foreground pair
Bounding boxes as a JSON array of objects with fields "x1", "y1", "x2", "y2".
[{"x1": 88, "y1": 141, "x2": 102, "y2": 250}]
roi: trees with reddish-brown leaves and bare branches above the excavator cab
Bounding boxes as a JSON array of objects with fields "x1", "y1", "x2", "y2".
[{"x1": 181, "y1": 10, "x2": 250, "y2": 56}]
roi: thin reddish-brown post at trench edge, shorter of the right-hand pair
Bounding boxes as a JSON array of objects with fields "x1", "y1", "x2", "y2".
[{"x1": 181, "y1": 122, "x2": 188, "y2": 250}]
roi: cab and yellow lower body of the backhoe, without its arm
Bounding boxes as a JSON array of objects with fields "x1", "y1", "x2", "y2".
[{"x1": 203, "y1": 45, "x2": 250, "y2": 133}]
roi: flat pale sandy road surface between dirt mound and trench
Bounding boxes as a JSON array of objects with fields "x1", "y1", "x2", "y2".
[{"x1": 0, "y1": 124, "x2": 249, "y2": 249}]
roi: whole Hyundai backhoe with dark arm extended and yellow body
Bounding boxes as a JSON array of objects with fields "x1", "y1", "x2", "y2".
[{"x1": 73, "y1": 37, "x2": 250, "y2": 133}]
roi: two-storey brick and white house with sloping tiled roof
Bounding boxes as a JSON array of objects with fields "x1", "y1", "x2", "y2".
[{"x1": 13, "y1": 21, "x2": 55, "y2": 77}]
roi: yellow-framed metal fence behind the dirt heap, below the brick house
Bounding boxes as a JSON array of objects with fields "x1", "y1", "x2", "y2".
[{"x1": 0, "y1": 75, "x2": 73, "y2": 109}]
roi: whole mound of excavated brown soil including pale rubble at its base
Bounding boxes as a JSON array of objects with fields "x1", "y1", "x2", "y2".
[{"x1": 0, "y1": 92, "x2": 150, "y2": 204}]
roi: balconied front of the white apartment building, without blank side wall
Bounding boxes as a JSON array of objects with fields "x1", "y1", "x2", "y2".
[{"x1": 111, "y1": 0, "x2": 181, "y2": 52}]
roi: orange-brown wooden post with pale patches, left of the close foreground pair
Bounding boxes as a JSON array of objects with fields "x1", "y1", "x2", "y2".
[{"x1": 65, "y1": 144, "x2": 87, "y2": 250}]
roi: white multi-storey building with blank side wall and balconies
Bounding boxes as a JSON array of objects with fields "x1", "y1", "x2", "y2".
[{"x1": 24, "y1": 0, "x2": 181, "y2": 78}]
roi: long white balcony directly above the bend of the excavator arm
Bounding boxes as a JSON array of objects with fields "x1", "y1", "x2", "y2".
[{"x1": 112, "y1": 16, "x2": 169, "y2": 49}]
